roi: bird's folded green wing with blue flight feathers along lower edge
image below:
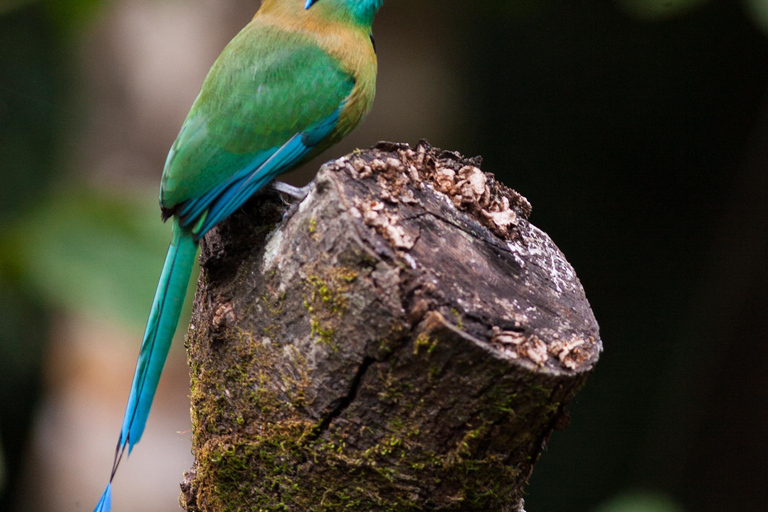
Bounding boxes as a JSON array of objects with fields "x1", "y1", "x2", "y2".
[{"x1": 160, "y1": 23, "x2": 355, "y2": 236}]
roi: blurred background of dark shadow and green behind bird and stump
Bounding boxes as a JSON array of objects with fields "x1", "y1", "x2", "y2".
[{"x1": 0, "y1": 0, "x2": 768, "y2": 512}]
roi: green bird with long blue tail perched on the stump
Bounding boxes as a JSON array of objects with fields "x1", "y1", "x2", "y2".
[{"x1": 94, "y1": 0, "x2": 383, "y2": 512}]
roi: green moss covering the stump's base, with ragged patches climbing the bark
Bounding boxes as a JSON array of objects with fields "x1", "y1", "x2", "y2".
[{"x1": 195, "y1": 341, "x2": 519, "y2": 512}]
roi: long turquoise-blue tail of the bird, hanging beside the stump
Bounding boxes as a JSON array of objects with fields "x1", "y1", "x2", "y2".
[{"x1": 94, "y1": 218, "x2": 197, "y2": 512}]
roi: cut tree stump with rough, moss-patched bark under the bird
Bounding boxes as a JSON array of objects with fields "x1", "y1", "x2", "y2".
[{"x1": 181, "y1": 143, "x2": 602, "y2": 512}]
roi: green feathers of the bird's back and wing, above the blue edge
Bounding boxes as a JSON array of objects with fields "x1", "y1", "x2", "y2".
[{"x1": 160, "y1": 23, "x2": 354, "y2": 209}]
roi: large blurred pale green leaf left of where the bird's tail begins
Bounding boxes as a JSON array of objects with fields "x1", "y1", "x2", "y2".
[{"x1": 0, "y1": 190, "x2": 186, "y2": 329}]
